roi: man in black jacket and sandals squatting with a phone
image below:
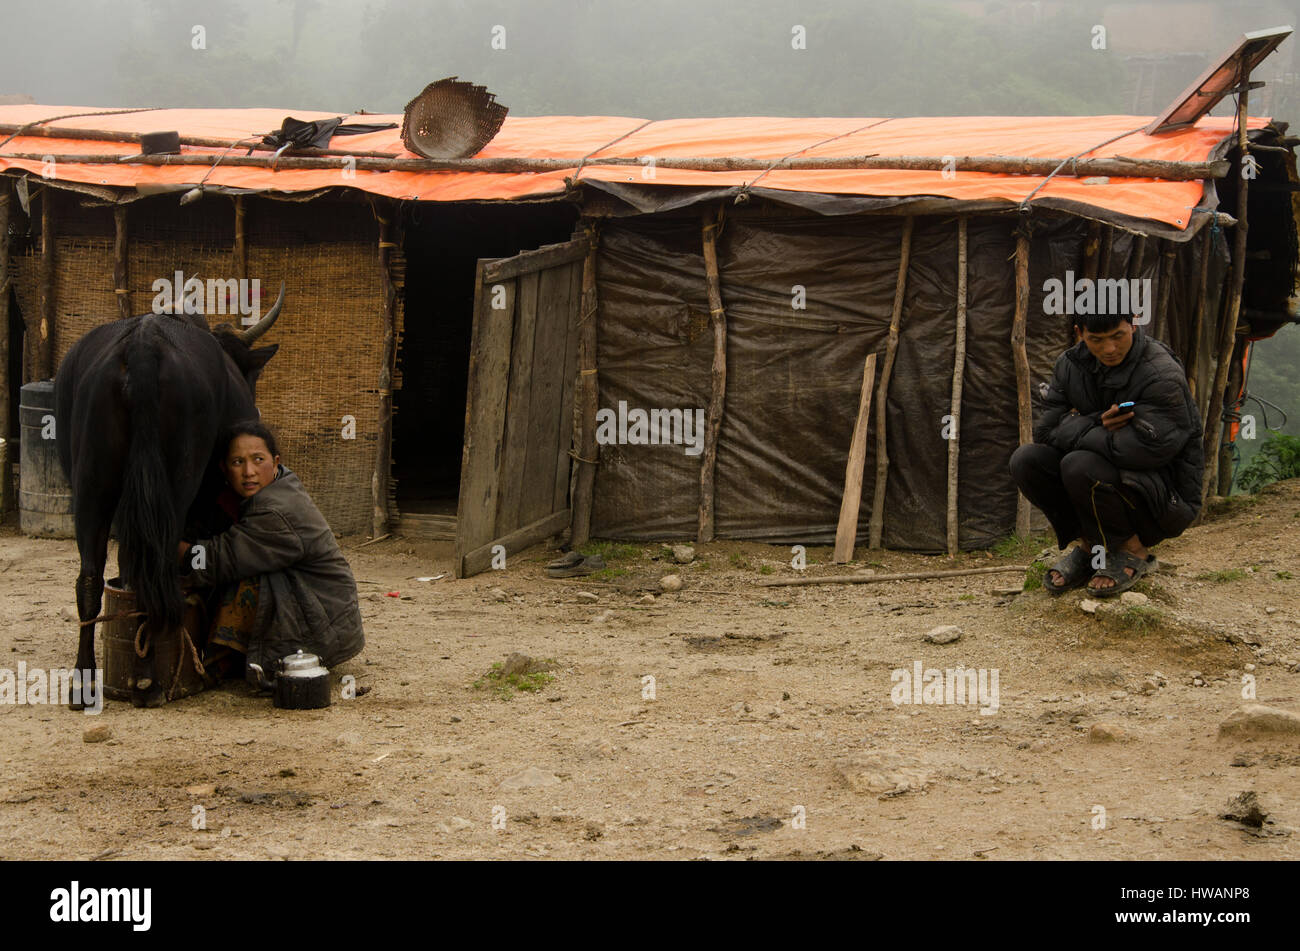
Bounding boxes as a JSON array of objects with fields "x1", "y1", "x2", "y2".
[{"x1": 1010, "y1": 309, "x2": 1205, "y2": 598}]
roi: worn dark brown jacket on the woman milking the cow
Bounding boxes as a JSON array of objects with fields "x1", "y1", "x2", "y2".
[{"x1": 183, "y1": 465, "x2": 365, "y2": 673}]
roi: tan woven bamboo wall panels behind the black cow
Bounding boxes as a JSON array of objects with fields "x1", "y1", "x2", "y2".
[{"x1": 14, "y1": 189, "x2": 402, "y2": 535}]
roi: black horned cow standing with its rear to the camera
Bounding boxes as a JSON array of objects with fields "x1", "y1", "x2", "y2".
[{"x1": 55, "y1": 285, "x2": 285, "y2": 707}]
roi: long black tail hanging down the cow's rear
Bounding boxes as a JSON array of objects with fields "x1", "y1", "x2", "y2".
[{"x1": 117, "y1": 321, "x2": 185, "y2": 631}]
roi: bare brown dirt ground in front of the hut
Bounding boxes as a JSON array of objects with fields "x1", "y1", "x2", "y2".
[{"x1": 0, "y1": 481, "x2": 1300, "y2": 860}]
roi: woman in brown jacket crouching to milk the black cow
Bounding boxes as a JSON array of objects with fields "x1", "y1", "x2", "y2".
[{"x1": 179, "y1": 421, "x2": 365, "y2": 682}]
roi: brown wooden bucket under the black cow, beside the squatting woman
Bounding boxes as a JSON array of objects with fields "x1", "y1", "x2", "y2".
[{"x1": 100, "y1": 578, "x2": 204, "y2": 700}]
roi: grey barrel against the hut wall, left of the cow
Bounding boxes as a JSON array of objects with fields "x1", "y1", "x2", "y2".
[{"x1": 18, "y1": 379, "x2": 75, "y2": 538}]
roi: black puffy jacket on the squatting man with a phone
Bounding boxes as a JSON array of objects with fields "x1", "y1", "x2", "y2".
[{"x1": 1034, "y1": 329, "x2": 1205, "y2": 538}]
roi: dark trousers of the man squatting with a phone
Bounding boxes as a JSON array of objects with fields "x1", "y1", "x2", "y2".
[{"x1": 1010, "y1": 443, "x2": 1167, "y2": 551}]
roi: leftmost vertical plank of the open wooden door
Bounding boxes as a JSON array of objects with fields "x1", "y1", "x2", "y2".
[{"x1": 455, "y1": 261, "x2": 515, "y2": 577}]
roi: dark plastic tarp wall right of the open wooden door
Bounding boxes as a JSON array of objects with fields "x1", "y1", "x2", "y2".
[{"x1": 592, "y1": 208, "x2": 1223, "y2": 551}]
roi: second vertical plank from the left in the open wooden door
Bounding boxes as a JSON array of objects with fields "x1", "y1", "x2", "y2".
[{"x1": 493, "y1": 272, "x2": 545, "y2": 535}]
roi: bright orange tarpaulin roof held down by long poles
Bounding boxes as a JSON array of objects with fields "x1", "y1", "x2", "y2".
[{"x1": 0, "y1": 105, "x2": 1269, "y2": 230}]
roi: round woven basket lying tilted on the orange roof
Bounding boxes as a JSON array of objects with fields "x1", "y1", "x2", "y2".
[{"x1": 402, "y1": 75, "x2": 510, "y2": 159}]
